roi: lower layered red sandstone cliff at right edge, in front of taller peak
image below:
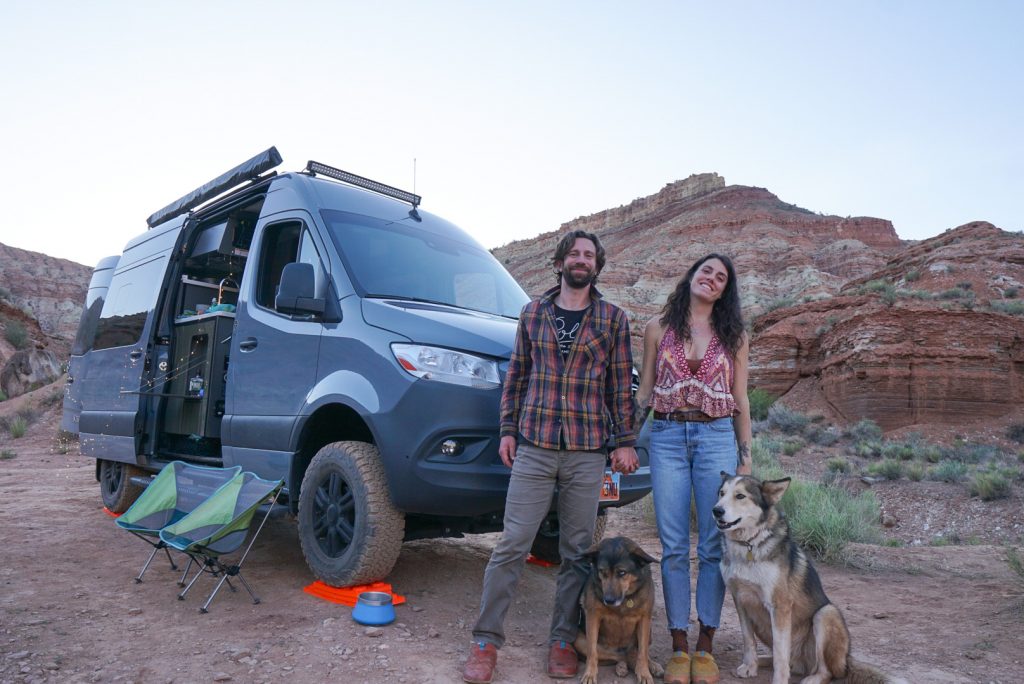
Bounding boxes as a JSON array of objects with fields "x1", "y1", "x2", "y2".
[{"x1": 751, "y1": 223, "x2": 1024, "y2": 429}]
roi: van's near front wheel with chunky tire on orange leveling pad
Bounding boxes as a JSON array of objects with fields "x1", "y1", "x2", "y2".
[{"x1": 298, "y1": 441, "x2": 406, "y2": 587}]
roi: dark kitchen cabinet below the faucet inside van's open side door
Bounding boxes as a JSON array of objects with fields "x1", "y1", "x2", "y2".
[{"x1": 164, "y1": 311, "x2": 234, "y2": 438}]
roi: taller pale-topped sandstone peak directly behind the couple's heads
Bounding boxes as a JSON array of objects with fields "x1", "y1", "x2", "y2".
[{"x1": 494, "y1": 173, "x2": 903, "y2": 362}]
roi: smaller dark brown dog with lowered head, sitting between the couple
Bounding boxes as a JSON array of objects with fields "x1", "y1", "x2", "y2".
[{"x1": 573, "y1": 537, "x2": 665, "y2": 684}]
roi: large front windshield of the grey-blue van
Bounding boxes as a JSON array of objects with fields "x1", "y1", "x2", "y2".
[{"x1": 322, "y1": 210, "x2": 529, "y2": 318}]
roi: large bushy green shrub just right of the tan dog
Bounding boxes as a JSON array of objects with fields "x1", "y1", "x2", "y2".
[{"x1": 781, "y1": 480, "x2": 881, "y2": 562}]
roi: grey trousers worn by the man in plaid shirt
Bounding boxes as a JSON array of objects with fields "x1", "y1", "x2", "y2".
[{"x1": 473, "y1": 444, "x2": 605, "y2": 648}]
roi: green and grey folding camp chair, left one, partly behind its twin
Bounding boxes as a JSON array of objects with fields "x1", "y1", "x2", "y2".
[{"x1": 115, "y1": 461, "x2": 242, "y2": 585}]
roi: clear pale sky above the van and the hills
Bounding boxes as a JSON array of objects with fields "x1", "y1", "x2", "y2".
[{"x1": 0, "y1": 0, "x2": 1024, "y2": 265}]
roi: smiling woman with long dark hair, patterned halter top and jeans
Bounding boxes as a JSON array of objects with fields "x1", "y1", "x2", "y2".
[{"x1": 637, "y1": 254, "x2": 751, "y2": 684}]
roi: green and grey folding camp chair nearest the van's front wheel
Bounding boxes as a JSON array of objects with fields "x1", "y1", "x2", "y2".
[{"x1": 160, "y1": 472, "x2": 285, "y2": 612}]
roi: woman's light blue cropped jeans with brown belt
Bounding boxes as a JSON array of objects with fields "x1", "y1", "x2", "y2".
[{"x1": 650, "y1": 418, "x2": 737, "y2": 630}]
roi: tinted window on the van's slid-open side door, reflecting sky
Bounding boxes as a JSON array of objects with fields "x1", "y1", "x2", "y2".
[{"x1": 93, "y1": 256, "x2": 167, "y2": 349}]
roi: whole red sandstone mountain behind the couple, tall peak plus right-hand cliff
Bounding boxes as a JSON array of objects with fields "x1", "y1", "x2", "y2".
[{"x1": 494, "y1": 180, "x2": 1024, "y2": 429}]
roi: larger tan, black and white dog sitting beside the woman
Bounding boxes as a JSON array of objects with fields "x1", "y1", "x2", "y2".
[{"x1": 712, "y1": 472, "x2": 903, "y2": 684}]
